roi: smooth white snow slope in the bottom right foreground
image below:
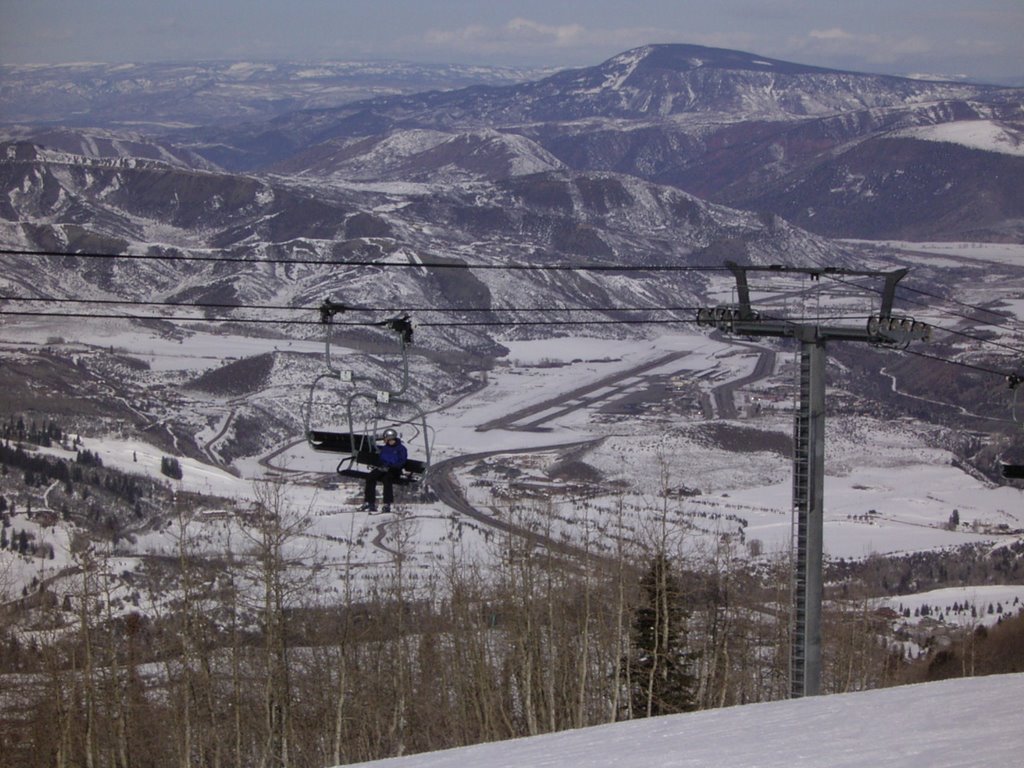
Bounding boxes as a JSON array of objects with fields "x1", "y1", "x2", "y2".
[{"x1": 339, "y1": 675, "x2": 1024, "y2": 768}]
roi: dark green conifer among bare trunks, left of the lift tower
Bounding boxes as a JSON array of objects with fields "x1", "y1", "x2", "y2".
[{"x1": 624, "y1": 553, "x2": 696, "y2": 718}]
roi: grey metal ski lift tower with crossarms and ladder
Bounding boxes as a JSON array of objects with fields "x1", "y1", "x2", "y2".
[{"x1": 697, "y1": 261, "x2": 931, "y2": 698}]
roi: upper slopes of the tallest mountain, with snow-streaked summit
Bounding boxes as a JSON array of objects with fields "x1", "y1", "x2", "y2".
[{"x1": 239, "y1": 45, "x2": 1012, "y2": 134}]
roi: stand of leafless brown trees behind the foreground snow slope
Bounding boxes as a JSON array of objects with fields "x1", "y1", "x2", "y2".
[{"x1": 0, "y1": 484, "x2": 925, "y2": 768}]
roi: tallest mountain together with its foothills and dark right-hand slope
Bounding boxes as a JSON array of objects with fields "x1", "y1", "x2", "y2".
[{"x1": 105, "y1": 45, "x2": 1024, "y2": 241}]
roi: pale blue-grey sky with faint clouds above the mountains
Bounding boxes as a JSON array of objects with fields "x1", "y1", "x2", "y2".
[{"x1": 0, "y1": 0, "x2": 1024, "y2": 82}]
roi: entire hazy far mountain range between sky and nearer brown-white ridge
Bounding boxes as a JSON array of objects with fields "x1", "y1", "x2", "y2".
[{"x1": 2, "y1": 45, "x2": 1024, "y2": 241}]
